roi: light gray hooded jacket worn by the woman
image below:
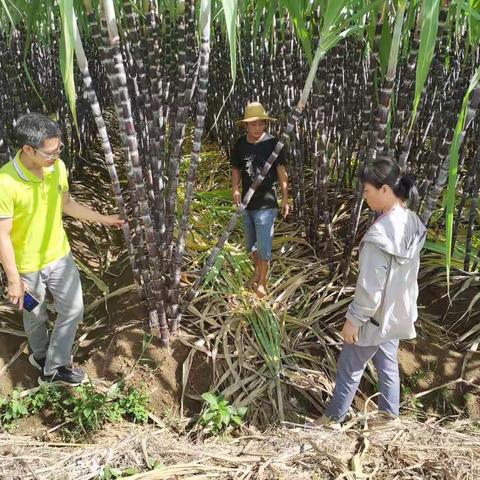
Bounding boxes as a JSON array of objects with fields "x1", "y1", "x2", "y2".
[{"x1": 346, "y1": 208, "x2": 427, "y2": 346}]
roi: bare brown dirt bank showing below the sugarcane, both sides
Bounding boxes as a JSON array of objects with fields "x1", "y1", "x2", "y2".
[{"x1": 0, "y1": 316, "x2": 480, "y2": 433}]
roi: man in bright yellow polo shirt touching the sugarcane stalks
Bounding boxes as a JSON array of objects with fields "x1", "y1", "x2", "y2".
[{"x1": 0, "y1": 113, "x2": 124, "y2": 385}]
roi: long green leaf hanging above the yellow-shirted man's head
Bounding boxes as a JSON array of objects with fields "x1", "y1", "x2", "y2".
[{"x1": 59, "y1": 0, "x2": 80, "y2": 139}]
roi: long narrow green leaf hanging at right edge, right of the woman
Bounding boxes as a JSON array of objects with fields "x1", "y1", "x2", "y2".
[{"x1": 445, "y1": 67, "x2": 480, "y2": 286}]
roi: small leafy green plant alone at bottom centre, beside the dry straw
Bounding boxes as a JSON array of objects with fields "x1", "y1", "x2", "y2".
[{"x1": 199, "y1": 392, "x2": 247, "y2": 434}]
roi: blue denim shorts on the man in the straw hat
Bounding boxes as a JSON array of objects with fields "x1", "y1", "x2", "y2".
[{"x1": 243, "y1": 208, "x2": 278, "y2": 260}]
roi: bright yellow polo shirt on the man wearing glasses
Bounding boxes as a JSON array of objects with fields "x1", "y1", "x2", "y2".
[{"x1": 0, "y1": 152, "x2": 70, "y2": 273}]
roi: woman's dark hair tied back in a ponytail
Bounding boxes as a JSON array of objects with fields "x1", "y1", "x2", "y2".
[{"x1": 358, "y1": 160, "x2": 419, "y2": 209}]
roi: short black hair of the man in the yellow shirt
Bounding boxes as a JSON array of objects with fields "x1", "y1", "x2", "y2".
[{"x1": 13, "y1": 113, "x2": 62, "y2": 148}]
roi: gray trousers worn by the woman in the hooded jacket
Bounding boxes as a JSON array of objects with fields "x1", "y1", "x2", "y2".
[{"x1": 325, "y1": 340, "x2": 400, "y2": 422}]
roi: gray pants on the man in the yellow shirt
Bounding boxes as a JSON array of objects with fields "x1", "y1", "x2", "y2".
[{"x1": 21, "y1": 253, "x2": 83, "y2": 375}]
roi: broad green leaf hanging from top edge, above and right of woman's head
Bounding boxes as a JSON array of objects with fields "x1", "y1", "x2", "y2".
[{"x1": 412, "y1": 0, "x2": 440, "y2": 121}]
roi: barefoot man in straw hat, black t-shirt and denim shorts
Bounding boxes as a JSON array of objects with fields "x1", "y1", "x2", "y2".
[{"x1": 231, "y1": 102, "x2": 289, "y2": 298}]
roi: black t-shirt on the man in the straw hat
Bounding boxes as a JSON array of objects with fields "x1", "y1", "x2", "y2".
[{"x1": 231, "y1": 133, "x2": 285, "y2": 210}]
